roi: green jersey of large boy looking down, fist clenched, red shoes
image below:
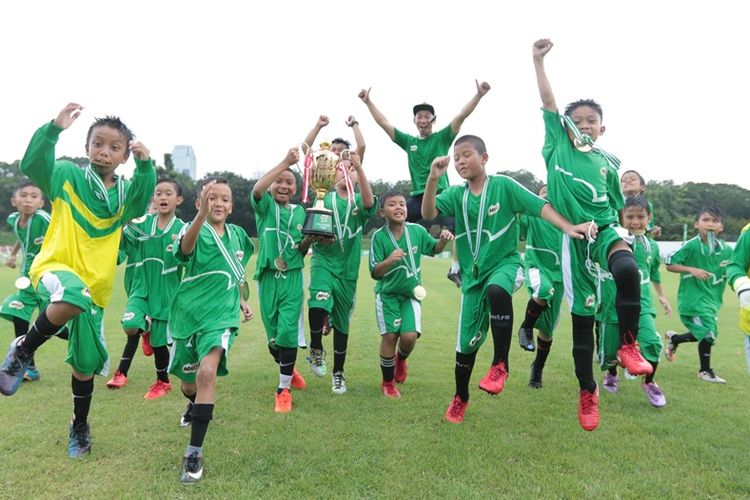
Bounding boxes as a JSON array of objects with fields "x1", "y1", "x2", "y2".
[{"x1": 435, "y1": 175, "x2": 547, "y2": 290}]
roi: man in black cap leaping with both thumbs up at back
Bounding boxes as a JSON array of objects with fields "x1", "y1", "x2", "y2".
[{"x1": 359, "y1": 80, "x2": 490, "y2": 288}]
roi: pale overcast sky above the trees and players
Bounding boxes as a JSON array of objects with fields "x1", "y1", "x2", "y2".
[{"x1": 0, "y1": 0, "x2": 750, "y2": 188}]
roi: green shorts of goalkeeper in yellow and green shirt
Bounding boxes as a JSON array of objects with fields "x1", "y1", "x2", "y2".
[{"x1": 36, "y1": 271, "x2": 109, "y2": 376}]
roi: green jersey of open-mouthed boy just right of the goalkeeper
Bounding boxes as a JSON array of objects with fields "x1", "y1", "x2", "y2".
[{"x1": 123, "y1": 214, "x2": 185, "y2": 320}]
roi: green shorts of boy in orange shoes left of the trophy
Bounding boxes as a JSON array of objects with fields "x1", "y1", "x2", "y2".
[{"x1": 258, "y1": 269, "x2": 307, "y2": 348}]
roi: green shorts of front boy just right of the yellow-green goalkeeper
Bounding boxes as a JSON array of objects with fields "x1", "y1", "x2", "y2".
[{"x1": 168, "y1": 328, "x2": 237, "y2": 384}]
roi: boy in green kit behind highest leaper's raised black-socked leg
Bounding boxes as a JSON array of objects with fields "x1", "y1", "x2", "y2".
[{"x1": 596, "y1": 196, "x2": 672, "y2": 408}]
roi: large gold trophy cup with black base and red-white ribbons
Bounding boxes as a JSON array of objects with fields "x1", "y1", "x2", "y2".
[{"x1": 301, "y1": 142, "x2": 349, "y2": 238}]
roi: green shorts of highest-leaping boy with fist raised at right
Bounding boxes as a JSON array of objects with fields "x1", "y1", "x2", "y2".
[{"x1": 561, "y1": 226, "x2": 624, "y2": 316}]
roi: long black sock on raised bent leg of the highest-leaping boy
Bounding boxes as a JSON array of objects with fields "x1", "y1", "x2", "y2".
[{"x1": 608, "y1": 250, "x2": 641, "y2": 344}]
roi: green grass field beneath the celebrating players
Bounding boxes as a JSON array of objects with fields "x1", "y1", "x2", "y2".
[{"x1": 0, "y1": 259, "x2": 750, "y2": 498}]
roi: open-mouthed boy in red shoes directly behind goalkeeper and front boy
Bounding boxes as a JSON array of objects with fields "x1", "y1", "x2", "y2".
[{"x1": 107, "y1": 178, "x2": 185, "y2": 399}]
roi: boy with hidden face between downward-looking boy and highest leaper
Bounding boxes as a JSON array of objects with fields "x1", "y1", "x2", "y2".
[{"x1": 518, "y1": 185, "x2": 563, "y2": 389}]
